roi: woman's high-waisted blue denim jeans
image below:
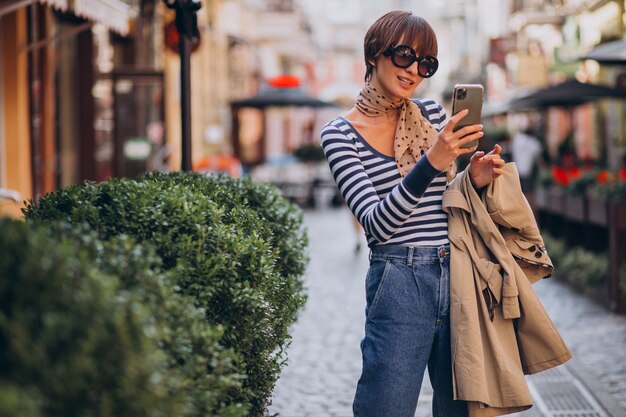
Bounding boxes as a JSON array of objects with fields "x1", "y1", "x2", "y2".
[{"x1": 352, "y1": 245, "x2": 467, "y2": 417}]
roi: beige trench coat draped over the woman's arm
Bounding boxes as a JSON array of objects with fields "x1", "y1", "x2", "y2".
[{"x1": 443, "y1": 163, "x2": 571, "y2": 417}]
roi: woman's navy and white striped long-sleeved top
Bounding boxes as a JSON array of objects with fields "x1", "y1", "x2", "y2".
[{"x1": 321, "y1": 99, "x2": 448, "y2": 247}]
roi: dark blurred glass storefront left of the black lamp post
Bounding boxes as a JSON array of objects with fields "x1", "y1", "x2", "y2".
[{"x1": 56, "y1": 2, "x2": 164, "y2": 182}]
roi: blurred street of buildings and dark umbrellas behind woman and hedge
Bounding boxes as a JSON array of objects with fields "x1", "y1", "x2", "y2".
[{"x1": 0, "y1": 0, "x2": 626, "y2": 218}]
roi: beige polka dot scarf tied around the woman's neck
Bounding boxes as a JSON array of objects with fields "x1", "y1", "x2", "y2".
[{"x1": 356, "y1": 83, "x2": 450, "y2": 178}]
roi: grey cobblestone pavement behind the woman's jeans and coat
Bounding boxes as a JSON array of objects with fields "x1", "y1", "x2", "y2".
[{"x1": 270, "y1": 208, "x2": 626, "y2": 417}]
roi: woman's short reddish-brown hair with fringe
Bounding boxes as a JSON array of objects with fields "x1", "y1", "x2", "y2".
[{"x1": 363, "y1": 10, "x2": 438, "y2": 81}]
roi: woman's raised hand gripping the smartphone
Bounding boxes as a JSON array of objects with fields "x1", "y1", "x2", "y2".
[{"x1": 426, "y1": 109, "x2": 483, "y2": 171}]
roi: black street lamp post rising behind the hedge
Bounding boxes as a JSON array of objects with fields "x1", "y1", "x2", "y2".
[{"x1": 164, "y1": 0, "x2": 202, "y2": 171}]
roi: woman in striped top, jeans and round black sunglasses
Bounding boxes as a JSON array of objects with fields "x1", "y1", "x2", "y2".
[{"x1": 321, "y1": 11, "x2": 504, "y2": 417}]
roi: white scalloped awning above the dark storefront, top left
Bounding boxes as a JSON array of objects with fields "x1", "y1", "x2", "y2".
[{"x1": 73, "y1": 0, "x2": 136, "y2": 36}]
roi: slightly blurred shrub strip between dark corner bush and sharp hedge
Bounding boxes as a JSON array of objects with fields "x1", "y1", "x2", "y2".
[{"x1": 47, "y1": 223, "x2": 247, "y2": 417}]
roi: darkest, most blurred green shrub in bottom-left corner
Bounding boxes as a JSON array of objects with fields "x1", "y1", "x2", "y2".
[{"x1": 0, "y1": 219, "x2": 171, "y2": 417}]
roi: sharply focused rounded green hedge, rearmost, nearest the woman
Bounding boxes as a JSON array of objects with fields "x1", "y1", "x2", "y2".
[{"x1": 24, "y1": 173, "x2": 307, "y2": 416}]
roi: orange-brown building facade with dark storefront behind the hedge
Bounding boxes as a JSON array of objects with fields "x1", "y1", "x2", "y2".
[{"x1": 0, "y1": 0, "x2": 163, "y2": 216}]
